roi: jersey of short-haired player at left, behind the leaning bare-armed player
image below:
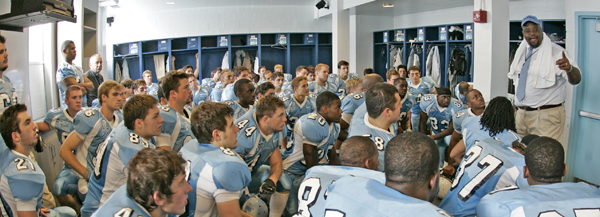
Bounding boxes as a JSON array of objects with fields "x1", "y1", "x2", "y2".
[{"x1": 44, "y1": 108, "x2": 75, "y2": 144}]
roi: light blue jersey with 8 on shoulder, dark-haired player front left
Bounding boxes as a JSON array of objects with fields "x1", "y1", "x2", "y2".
[{"x1": 81, "y1": 123, "x2": 155, "y2": 212}]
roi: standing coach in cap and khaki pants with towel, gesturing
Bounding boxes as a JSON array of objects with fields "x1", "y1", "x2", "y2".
[{"x1": 508, "y1": 16, "x2": 581, "y2": 140}]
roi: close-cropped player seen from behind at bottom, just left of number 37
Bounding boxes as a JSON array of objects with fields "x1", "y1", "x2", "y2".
[{"x1": 325, "y1": 133, "x2": 448, "y2": 217}]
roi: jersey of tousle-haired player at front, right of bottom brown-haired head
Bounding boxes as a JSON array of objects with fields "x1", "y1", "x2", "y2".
[{"x1": 179, "y1": 140, "x2": 251, "y2": 217}]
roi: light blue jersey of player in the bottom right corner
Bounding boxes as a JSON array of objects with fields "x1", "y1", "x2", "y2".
[{"x1": 477, "y1": 183, "x2": 600, "y2": 217}]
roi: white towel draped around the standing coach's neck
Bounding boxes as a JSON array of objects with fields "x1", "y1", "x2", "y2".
[{"x1": 508, "y1": 33, "x2": 562, "y2": 88}]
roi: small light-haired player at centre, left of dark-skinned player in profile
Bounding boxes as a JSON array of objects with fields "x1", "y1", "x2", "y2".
[{"x1": 281, "y1": 76, "x2": 317, "y2": 149}]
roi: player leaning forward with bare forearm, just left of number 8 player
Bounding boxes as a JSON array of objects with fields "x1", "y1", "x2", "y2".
[{"x1": 61, "y1": 81, "x2": 125, "y2": 216}]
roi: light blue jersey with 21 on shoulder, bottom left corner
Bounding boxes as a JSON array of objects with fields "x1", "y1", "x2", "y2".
[{"x1": 0, "y1": 151, "x2": 46, "y2": 216}]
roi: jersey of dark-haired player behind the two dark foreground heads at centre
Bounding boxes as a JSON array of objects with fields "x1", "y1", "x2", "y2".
[{"x1": 348, "y1": 108, "x2": 398, "y2": 171}]
